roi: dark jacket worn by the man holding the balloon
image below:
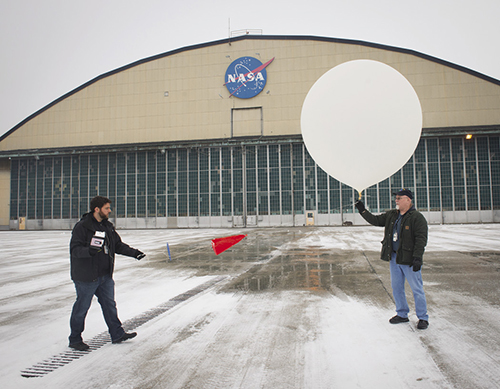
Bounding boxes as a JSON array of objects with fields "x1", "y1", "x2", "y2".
[{"x1": 361, "y1": 206, "x2": 428, "y2": 265}]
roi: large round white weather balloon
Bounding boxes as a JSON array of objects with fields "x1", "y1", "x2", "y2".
[{"x1": 301, "y1": 60, "x2": 422, "y2": 193}]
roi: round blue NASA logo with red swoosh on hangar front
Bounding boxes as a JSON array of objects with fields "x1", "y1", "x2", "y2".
[{"x1": 224, "y1": 57, "x2": 274, "y2": 99}]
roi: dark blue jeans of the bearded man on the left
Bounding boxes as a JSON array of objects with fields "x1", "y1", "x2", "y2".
[{"x1": 69, "y1": 276, "x2": 125, "y2": 344}]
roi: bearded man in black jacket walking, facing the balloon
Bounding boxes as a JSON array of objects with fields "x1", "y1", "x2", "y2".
[{"x1": 69, "y1": 196, "x2": 146, "y2": 351}]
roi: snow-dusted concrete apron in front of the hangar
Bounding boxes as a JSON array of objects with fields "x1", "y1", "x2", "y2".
[{"x1": 0, "y1": 224, "x2": 500, "y2": 389}]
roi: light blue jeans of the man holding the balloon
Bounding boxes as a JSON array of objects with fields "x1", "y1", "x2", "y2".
[{"x1": 390, "y1": 253, "x2": 429, "y2": 320}]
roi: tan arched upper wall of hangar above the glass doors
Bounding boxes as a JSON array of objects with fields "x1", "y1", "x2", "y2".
[{"x1": 0, "y1": 35, "x2": 500, "y2": 156}]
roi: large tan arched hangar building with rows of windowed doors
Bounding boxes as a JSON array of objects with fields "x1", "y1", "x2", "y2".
[{"x1": 0, "y1": 35, "x2": 500, "y2": 229}]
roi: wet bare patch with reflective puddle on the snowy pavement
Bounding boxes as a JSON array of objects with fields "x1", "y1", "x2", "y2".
[{"x1": 141, "y1": 229, "x2": 386, "y2": 295}]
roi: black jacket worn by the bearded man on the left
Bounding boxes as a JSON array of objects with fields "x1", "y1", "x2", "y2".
[{"x1": 69, "y1": 213, "x2": 138, "y2": 282}]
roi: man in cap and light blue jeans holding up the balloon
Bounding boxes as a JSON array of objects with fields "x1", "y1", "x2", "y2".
[{"x1": 356, "y1": 189, "x2": 429, "y2": 330}]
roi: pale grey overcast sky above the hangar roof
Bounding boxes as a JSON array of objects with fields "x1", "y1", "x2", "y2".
[{"x1": 0, "y1": 0, "x2": 500, "y2": 135}]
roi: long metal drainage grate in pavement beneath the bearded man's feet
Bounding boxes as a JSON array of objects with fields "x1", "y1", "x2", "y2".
[{"x1": 21, "y1": 276, "x2": 226, "y2": 378}]
